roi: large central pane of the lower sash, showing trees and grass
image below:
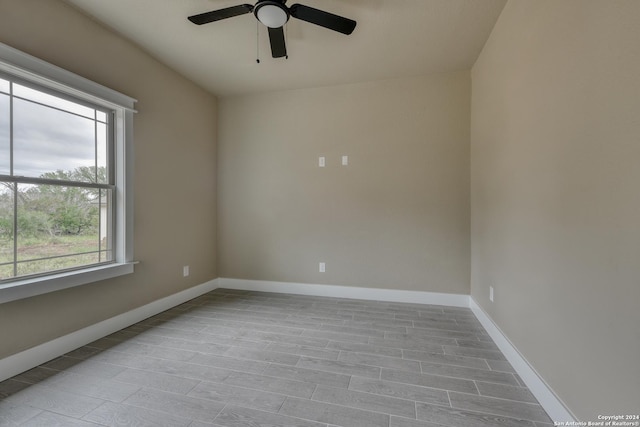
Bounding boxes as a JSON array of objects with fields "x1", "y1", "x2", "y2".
[{"x1": 17, "y1": 184, "x2": 101, "y2": 275}]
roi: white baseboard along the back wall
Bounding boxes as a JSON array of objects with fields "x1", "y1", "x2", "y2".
[{"x1": 218, "y1": 277, "x2": 469, "y2": 307}]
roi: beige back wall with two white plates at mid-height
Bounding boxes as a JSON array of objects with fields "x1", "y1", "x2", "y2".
[{"x1": 218, "y1": 72, "x2": 470, "y2": 294}]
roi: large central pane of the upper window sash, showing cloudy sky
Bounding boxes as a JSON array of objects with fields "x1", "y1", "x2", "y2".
[{"x1": 13, "y1": 99, "x2": 95, "y2": 182}]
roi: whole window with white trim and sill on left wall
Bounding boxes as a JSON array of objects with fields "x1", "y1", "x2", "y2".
[{"x1": 0, "y1": 44, "x2": 135, "y2": 302}]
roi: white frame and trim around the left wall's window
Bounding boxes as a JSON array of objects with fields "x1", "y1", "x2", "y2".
[{"x1": 0, "y1": 43, "x2": 136, "y2": 304}]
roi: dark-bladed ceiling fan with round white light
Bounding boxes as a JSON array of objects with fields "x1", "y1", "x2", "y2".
[{"x1": 188, "y1": 0, "x2": 356, "y2": 58}]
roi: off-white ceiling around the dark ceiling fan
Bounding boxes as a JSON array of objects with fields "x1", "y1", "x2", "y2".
[{"x1": 65, "y1": 0, "x2": 506, "y2": 96}]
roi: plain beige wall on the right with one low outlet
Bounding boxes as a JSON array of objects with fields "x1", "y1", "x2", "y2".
[{"x1": 471, "y1": 0, "x2": 640, "y2": 420}]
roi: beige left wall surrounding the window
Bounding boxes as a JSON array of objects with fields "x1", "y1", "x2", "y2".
[{"x1": 0, "y1": 0, "x2": 217, "y2": 358}]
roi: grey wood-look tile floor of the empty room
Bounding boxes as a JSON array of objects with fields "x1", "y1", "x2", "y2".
[{"x1": 0, "y1": 289, "x2": 552, "y2": 427}]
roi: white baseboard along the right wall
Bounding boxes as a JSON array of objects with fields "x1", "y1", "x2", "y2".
[{"x1": 469, "y1": 297, "x2": 576, "y2": 423}]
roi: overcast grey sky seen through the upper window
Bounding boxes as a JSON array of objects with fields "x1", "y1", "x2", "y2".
[{"x1": 0, "y1": 79, "x2": 107, "y2": 181}]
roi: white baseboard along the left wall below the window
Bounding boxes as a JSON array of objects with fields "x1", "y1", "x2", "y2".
[{"x1": 0, "y1": 279, "x2": 217, "y2": 381}]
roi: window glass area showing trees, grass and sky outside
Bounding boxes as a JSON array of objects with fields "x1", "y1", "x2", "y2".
[{"x1": 0, "y1": 76, "x2": 115, "y2": 280}]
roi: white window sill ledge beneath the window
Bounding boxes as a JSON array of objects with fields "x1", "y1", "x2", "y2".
[{"x1": 0, "y1": 262, "x2": 134, "y2": 304}]
